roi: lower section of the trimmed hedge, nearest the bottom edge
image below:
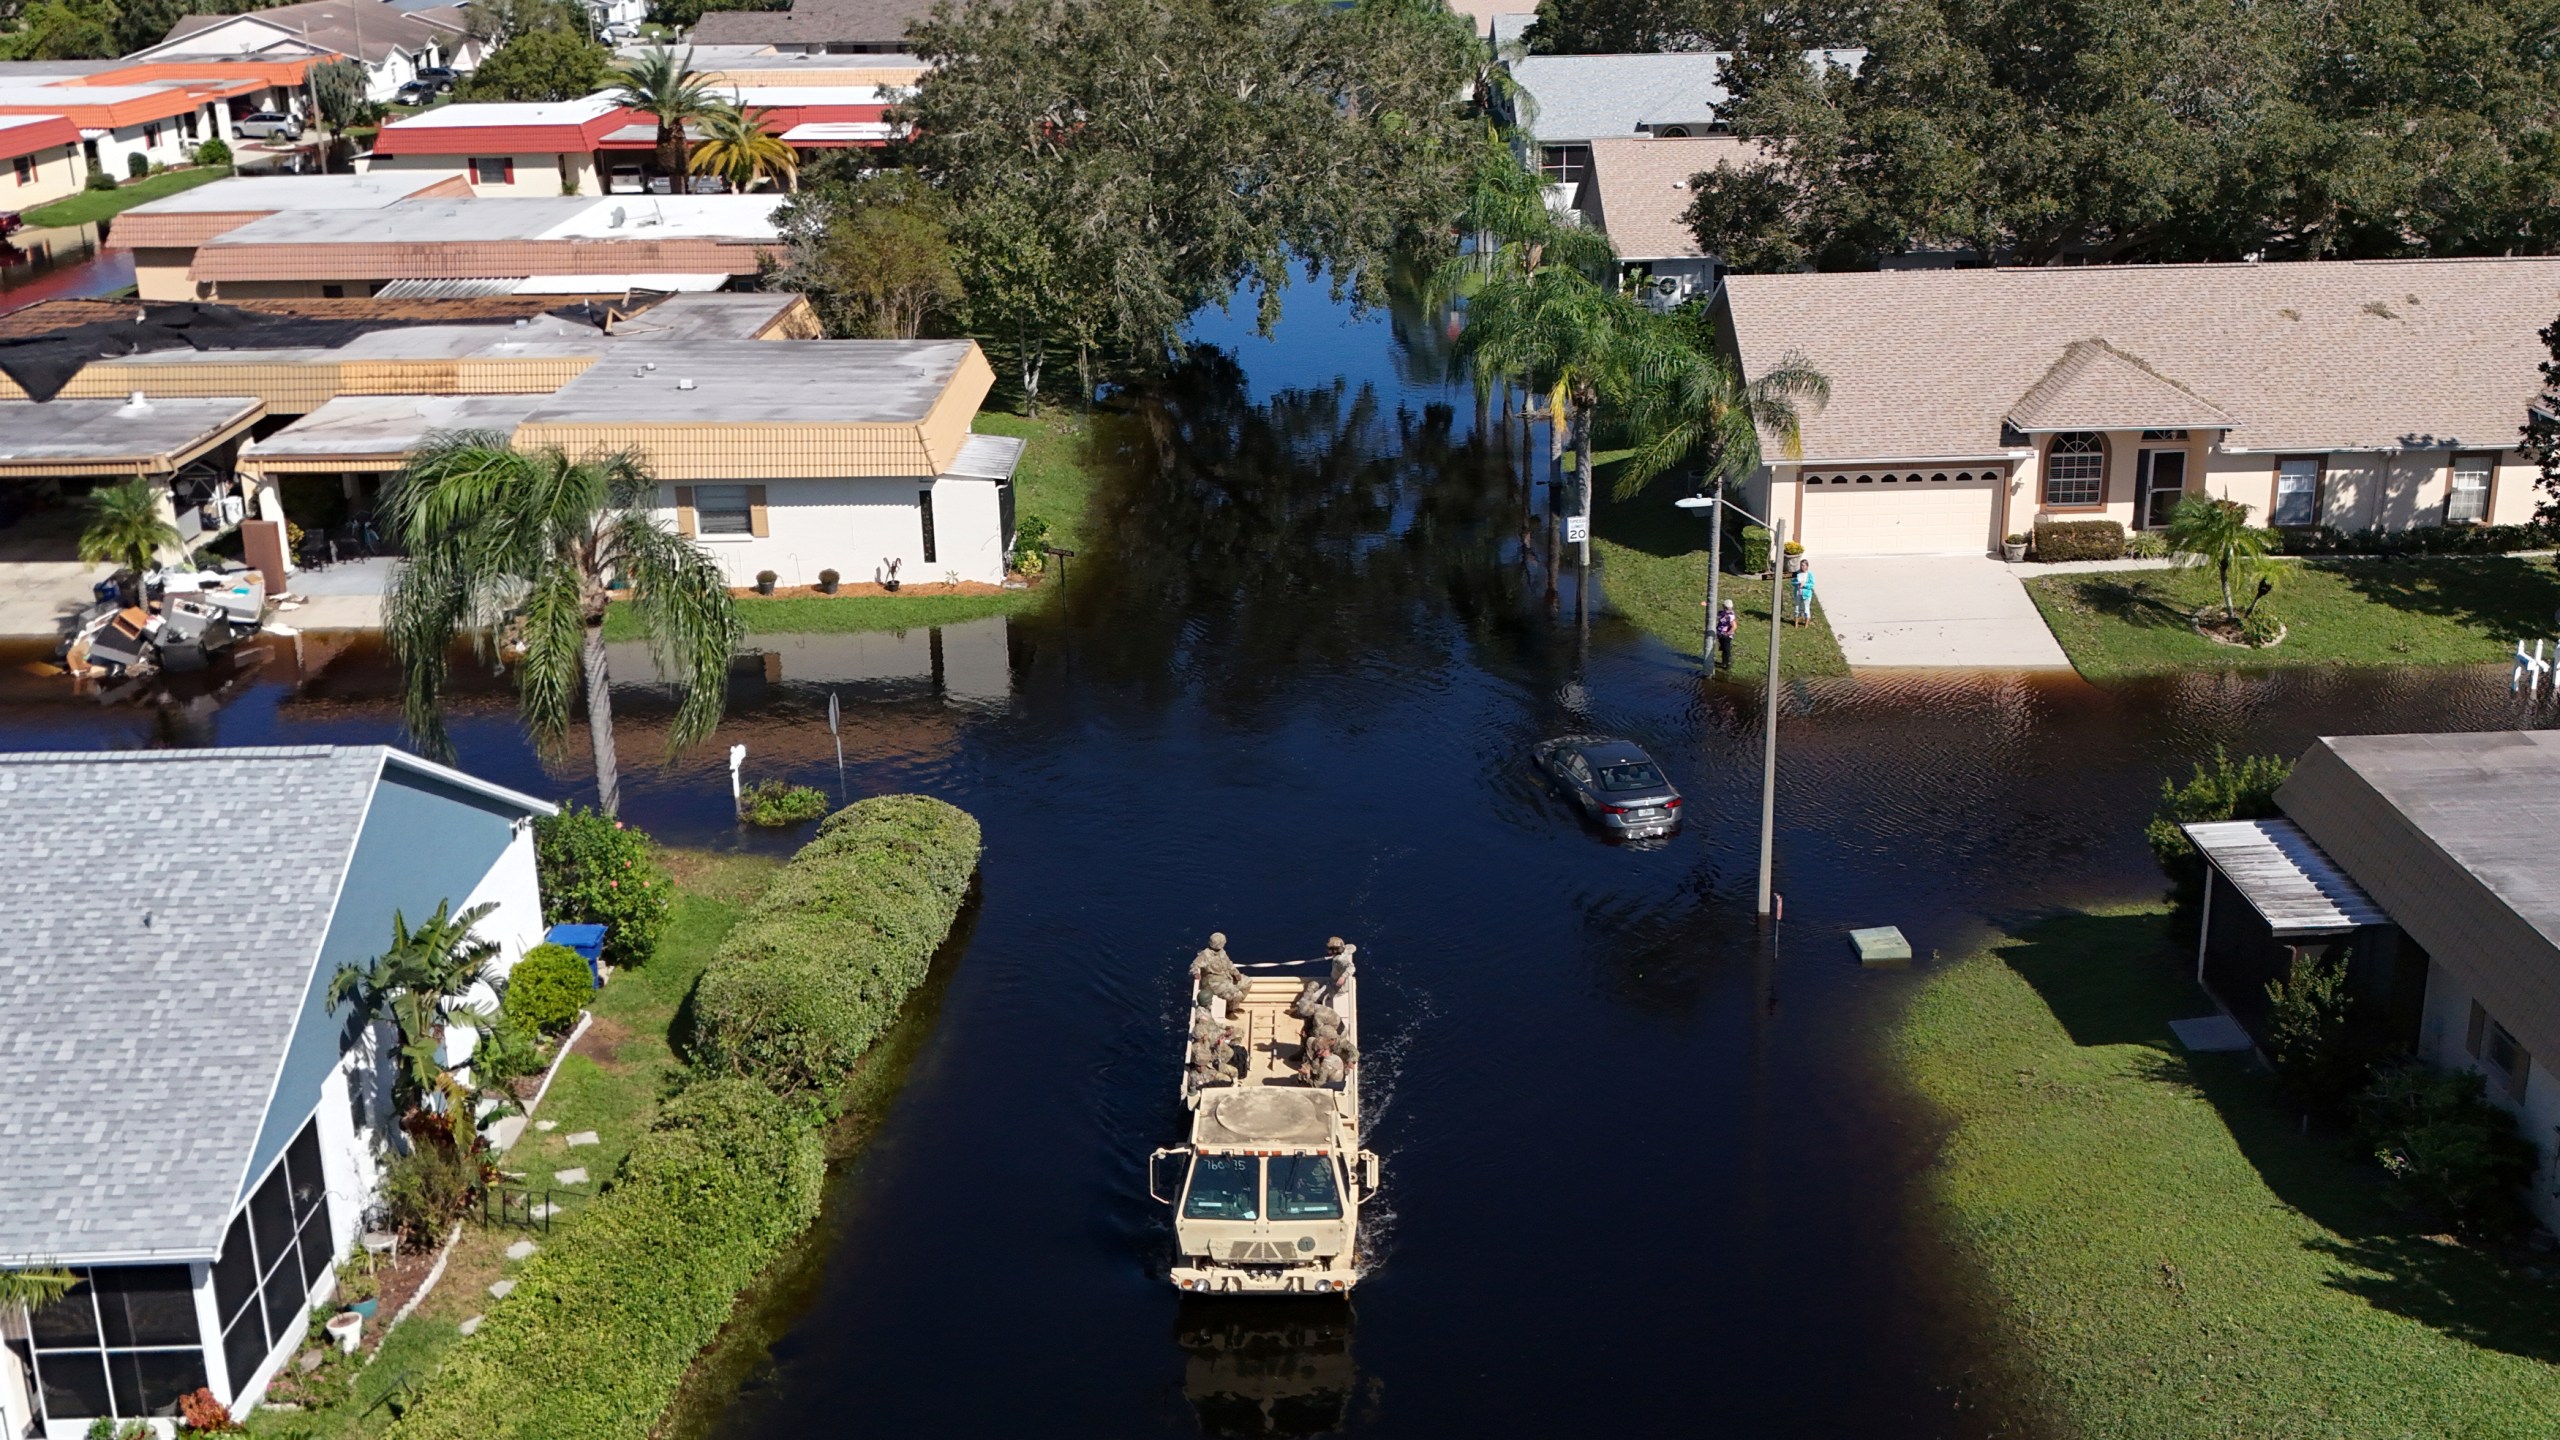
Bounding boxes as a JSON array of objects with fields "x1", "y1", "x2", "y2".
[{"x1": 392, "y1": 1079, "x2": 827, "y2": 1440}]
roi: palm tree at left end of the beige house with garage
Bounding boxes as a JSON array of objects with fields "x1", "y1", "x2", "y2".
[{"x1": 1618, "y1": 305, "x2": 1830, "y2": 500}]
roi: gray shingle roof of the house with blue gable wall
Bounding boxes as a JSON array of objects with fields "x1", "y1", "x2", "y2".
[{"x1": 0, "y1": 746, "x2": 548, "y2": 1263}]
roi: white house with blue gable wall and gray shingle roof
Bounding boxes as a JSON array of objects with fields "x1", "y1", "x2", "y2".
[{"x1": 0, "y1": 746, "x2": 553, "y2": 1440}]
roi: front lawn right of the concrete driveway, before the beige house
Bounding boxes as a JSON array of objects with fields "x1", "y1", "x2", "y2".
[{"x1": 2028, "y1": 556, "x2": 2560, "y2": 679}]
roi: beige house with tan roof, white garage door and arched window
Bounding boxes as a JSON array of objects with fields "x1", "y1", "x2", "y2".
[{"x1": 1718, "y1": 259, "x2": 2560, "y2": 553}]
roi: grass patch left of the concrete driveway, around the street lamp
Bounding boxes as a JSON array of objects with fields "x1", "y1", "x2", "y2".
[{"x1": 1592, "y1": 451, "x2": 1848, "y2": 679}]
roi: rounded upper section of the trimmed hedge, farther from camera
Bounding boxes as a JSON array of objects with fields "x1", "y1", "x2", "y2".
[{"x1": 691, "y1": 794, "x2": 978, "y2": 1097}]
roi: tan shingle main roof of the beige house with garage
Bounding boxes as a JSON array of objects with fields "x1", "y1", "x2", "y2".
[{"x1": 1725, "y1": 259, "x2": 2560, "y2": 461}]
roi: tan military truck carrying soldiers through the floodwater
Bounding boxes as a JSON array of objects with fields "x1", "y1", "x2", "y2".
[{"x1": 1147, "y1": 938, "x2": 1380, "y2": 1297}]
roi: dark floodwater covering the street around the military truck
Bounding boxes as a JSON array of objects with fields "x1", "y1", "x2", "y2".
[{"x1": 0, "y1": 274, "x2": 2522, "y2": 1437}]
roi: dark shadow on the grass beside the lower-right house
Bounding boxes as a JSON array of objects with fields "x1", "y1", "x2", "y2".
[{"x1": 1999, "y1": 912, "x2": 2560, "y2": 1363}]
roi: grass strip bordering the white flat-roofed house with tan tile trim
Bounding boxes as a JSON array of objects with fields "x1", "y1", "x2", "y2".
[{"x1": 604, "y1": 410, "x2": 1096, "y2": 641}]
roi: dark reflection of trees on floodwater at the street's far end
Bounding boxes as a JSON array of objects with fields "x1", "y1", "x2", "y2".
[{"x1": 1039, "y1": 346, "x2": 1526, "y2": 710}]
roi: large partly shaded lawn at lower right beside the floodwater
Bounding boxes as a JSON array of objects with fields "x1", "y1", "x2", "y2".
[{"x1": 1897, "y1": 910, "x2": 2560, "y2": 1440}]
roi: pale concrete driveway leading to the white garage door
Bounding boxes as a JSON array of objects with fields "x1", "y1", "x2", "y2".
[{"x1": 1812, "y1": 553, "x2": 2071, "y2": 669}]
